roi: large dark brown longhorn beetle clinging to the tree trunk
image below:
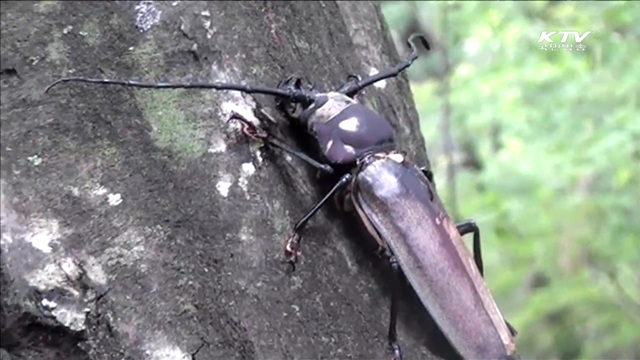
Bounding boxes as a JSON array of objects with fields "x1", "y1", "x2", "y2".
[{"x1": 45, "y1": 34, "x2": 519, "y2": 360}]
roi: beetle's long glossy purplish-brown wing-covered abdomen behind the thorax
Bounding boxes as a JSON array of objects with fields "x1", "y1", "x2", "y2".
[{"x1": 352, "y1": 154, "x2": 515, "y2": 359}]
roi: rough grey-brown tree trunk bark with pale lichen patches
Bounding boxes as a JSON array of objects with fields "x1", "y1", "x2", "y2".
[{"x1": 0, "y1": 1, "x2": 458, "y2": 360}]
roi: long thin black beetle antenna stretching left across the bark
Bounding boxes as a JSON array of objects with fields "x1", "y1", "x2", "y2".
[{"x1": 44, "y1": 77, "x2": 313, "y2": 103}]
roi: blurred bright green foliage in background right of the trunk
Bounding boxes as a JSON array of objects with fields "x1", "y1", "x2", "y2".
[{"x1": 382, "y1": 1, "x2": 640, "y2": 359}]
